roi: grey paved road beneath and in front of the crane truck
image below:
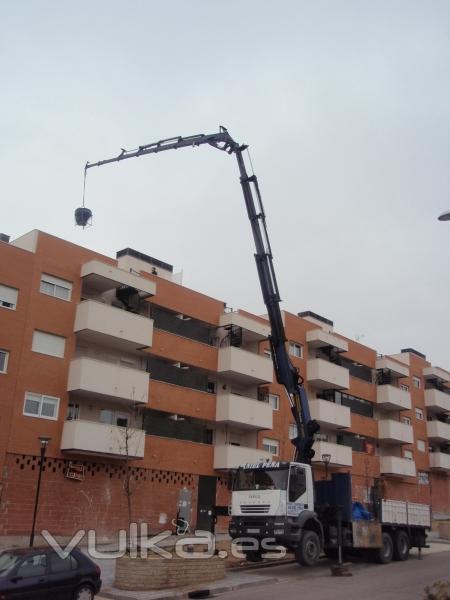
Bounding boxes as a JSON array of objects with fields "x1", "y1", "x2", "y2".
[{"x1": 219, "y1": 548, "x2": 450, "y2": 600}]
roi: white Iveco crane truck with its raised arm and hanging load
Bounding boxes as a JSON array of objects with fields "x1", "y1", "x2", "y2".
[{"x1": 80, "y1": 127, "x2": 431, "y2": 566}]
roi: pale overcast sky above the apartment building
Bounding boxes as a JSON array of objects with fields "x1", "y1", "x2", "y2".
[{"x1": 0, "y1": 0, "x2": 450, "y2": 368}]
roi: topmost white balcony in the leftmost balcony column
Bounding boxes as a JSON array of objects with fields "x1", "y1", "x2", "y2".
[{"x1": 81, "y1": 260, "x2": 156, "y2": 298}]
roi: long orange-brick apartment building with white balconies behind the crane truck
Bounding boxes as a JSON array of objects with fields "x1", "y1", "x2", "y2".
[{"x1": 0, "y1": 231, "x2": 450, "y2": 535}]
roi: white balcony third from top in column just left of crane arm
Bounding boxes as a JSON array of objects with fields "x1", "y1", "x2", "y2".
[{"x1": 216, "y1": 393, "x2": 273, "y2": 429}]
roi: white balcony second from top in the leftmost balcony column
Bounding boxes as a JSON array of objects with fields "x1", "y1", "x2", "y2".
[{"x1": 74, "y1": 300, "x2": 153, "y2": 351}]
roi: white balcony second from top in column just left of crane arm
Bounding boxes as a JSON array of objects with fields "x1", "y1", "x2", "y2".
[{"x1": 217, "y1": 346, "x2": 273, "y2": 385}]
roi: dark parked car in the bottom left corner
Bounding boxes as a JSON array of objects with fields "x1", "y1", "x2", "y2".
[{"x1": 0, "y1": 546, "x2": 102, "y2": 600}]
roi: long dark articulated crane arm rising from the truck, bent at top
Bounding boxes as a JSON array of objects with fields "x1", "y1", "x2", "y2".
[{"x1": 81, "y1": 127, "x2": 319, "y2": 464}]
